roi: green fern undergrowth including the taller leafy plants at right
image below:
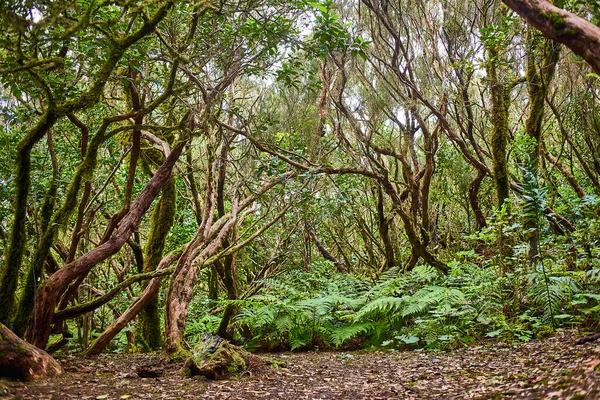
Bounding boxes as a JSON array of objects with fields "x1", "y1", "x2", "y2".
[{"x1": 188, "y1": 192, "x2": 600, "y2": 351}]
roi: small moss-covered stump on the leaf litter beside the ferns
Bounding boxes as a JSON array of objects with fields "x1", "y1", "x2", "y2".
[{"x1": 181, "y1": 335, "x2": 250, "y2": 379}]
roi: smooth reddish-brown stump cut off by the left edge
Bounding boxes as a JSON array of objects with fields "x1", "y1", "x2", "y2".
[{"x1": 0, "y1": 324, "x2": 62, "y2": 381}]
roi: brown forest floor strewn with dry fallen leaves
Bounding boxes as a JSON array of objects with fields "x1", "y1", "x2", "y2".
[{"x1": 0, "y1": 333, "x2": 600, "y2": 400}]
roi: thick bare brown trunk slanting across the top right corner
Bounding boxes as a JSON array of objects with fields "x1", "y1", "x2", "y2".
[{"x1": 503, "y1": 0, "x2": 600, "y2": 74}]
